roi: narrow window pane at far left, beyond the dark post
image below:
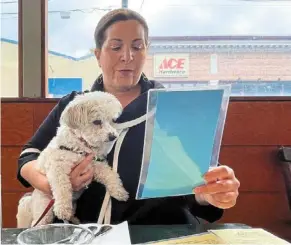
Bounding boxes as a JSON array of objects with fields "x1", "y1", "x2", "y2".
[{"x1": 0, "y1": 0, "x2": 19, "y2": 98}]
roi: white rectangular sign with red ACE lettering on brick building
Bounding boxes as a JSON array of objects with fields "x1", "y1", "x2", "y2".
[{"x1": 154, "y1": 54, "x2": 189, "y2": 77}]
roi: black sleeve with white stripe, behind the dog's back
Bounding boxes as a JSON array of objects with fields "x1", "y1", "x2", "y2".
[{"x1": 17, "y1": 92, "x2": 77, "y2": 187}]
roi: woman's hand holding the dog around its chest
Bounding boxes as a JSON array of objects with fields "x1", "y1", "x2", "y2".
[{"x1": 70, "y1": 155, "x2": 94, "y2": 191}]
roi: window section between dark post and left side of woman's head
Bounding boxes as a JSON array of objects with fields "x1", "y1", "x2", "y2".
[{"x1": 47, "y1": 0, "x2": 121, "y2": 98}]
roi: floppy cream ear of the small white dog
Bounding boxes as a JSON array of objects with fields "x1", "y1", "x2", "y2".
[{"x1": 60, "y1": 103, "x2": 88, "y2": 129}]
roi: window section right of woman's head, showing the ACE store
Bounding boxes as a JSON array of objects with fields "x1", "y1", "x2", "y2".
[{"x1": 129, "y1": 0, "x2": 291, "y2": 96}]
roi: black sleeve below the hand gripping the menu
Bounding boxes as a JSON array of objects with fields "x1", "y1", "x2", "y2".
[{"x1": 185, "y1": 195, "x2": 223, "y2": 222}]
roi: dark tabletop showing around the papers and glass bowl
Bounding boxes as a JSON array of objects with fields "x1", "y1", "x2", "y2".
[{"x1": 1, "y1": 223, "x2": 250, "y2": 244}]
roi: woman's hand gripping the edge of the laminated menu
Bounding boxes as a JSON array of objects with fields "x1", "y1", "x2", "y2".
[{"x1": 193, "y1": 166, "x2": 240, "y2": 209}]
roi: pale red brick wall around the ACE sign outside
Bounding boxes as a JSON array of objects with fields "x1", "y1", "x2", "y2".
[{"x1": 144, "y1": 52, "x2": 291, "y2": 81}]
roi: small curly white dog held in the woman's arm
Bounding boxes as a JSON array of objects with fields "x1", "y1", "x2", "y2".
[{"x1": 16, "y1": 91, "x2": 128, "y2": 228}]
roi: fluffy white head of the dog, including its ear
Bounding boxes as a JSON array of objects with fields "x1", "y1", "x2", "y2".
[{"x1": 60, "y1": 91, "x2": 122, "y2": 149}]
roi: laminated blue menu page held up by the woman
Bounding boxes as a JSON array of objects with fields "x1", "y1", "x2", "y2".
[{"x1": 136, "y1": 85, "x2": 230, "y2": 199}]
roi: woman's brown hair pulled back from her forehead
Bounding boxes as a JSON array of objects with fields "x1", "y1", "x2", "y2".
[{"x1": 94, "y1": 8, "x2": 149, "y2": 49}]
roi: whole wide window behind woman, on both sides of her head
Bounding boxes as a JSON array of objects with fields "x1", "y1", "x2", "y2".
[{"x1": 47, "y1": 0, "x2": 291, "y2": 97}]
